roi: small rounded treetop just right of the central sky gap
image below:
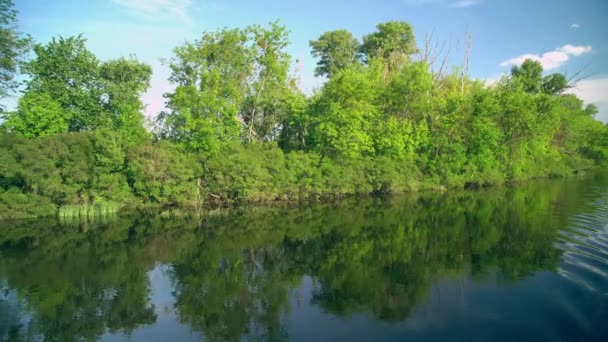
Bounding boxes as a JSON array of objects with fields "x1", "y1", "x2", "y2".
[{"x1": 309, "y1": 30, "x2": 360, "y2": 78}]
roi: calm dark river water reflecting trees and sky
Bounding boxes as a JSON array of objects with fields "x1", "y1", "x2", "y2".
[{"x1": 0, "y1": 175, "x2": 608, "y2": 341}]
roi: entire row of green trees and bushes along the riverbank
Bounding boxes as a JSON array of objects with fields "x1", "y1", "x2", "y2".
[{"x1": 0, "y1": 0, "x2": 608, "y2": 218}]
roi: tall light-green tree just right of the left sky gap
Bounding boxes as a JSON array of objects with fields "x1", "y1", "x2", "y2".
[{"x1": 158, "y1": 29, "x2": 253, "y2": 153}]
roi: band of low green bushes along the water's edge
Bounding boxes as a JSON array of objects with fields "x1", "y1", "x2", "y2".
[{"x1": 0, "y1": 133, "x2": 596, "y2": 220}]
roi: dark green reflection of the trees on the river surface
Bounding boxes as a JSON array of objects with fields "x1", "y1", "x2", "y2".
[{"x1": 0, "y1": 175, "x2": 597, "y2": 341}]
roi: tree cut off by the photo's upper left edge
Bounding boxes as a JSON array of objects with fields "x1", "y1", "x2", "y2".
[{"x1": 0, "y1": 0, "x2": 31, "y2": 105}]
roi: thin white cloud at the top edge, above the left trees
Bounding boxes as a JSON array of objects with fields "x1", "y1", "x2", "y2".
[{"x1": 112, "y1": 0, "x2": 192, "y2": 21}]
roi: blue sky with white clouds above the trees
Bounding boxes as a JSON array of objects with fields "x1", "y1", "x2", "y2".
[{"x1": 15, "y1": 0, "x2": 608, "y2": 122}]
